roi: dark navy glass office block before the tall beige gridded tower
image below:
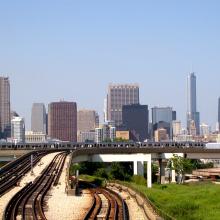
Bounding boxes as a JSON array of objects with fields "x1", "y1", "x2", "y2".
[{"x1": 122, "y1": 104, "x2": 149, "y2": 141}]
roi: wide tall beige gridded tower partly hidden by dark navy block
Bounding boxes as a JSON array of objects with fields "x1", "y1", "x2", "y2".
[{"x1": 106, "y1": 84, "x2": 139, "y2": 127}]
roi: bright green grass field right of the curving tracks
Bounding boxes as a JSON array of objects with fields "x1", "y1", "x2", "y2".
[{"x1": 123, "y1": 183, "x2": 220, "y2": 220}]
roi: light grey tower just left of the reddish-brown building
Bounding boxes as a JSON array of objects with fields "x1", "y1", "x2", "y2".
[{"x1": 31, "y1": 103, "x2": 46, "y2": 134}]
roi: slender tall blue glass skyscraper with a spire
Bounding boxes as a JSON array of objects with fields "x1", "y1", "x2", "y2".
[{"x1": 187, "y1": 73, "x2": 200, "y2": 135}]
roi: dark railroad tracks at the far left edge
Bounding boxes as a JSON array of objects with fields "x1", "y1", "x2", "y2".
[{"x1": 0, "y1": 152, "x2": 47, "y2": 197}]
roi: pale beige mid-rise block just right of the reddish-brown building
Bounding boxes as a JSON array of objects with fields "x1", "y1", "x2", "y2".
[{"x1": 77, "y1": 110, "x2": 99, "y2": 132}]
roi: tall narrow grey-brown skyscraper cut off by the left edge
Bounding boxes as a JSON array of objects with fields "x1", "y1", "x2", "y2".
[{"x1": 0, "y1": 77, "x2": 11, "y2": 138}]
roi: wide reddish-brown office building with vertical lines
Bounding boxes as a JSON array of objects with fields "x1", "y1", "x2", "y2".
[{"x1": 48, "y1": 101, "x2": 77, "y2": 142}]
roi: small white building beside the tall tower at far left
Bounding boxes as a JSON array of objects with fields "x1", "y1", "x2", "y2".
[{"x1": 11, "y1": 117, "x2": 25, "y2": 143}]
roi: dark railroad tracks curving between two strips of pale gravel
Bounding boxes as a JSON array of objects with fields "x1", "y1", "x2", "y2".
[{"x1": 4, "y1": 152, "x2": 68, "y2": 220}]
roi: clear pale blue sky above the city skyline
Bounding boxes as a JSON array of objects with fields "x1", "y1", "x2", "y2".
[{"x1": 0, "y1": 0, "x2": 220, "y2": 128}]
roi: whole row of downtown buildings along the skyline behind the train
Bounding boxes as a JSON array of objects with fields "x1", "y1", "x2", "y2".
[{"x1": 0, "y1": 73, "x2": 220, "y2": 143}]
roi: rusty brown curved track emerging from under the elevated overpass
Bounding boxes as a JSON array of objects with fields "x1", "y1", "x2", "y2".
[{"x1": 84, "y1": 185, "x2": 129, "y2": 220}]
